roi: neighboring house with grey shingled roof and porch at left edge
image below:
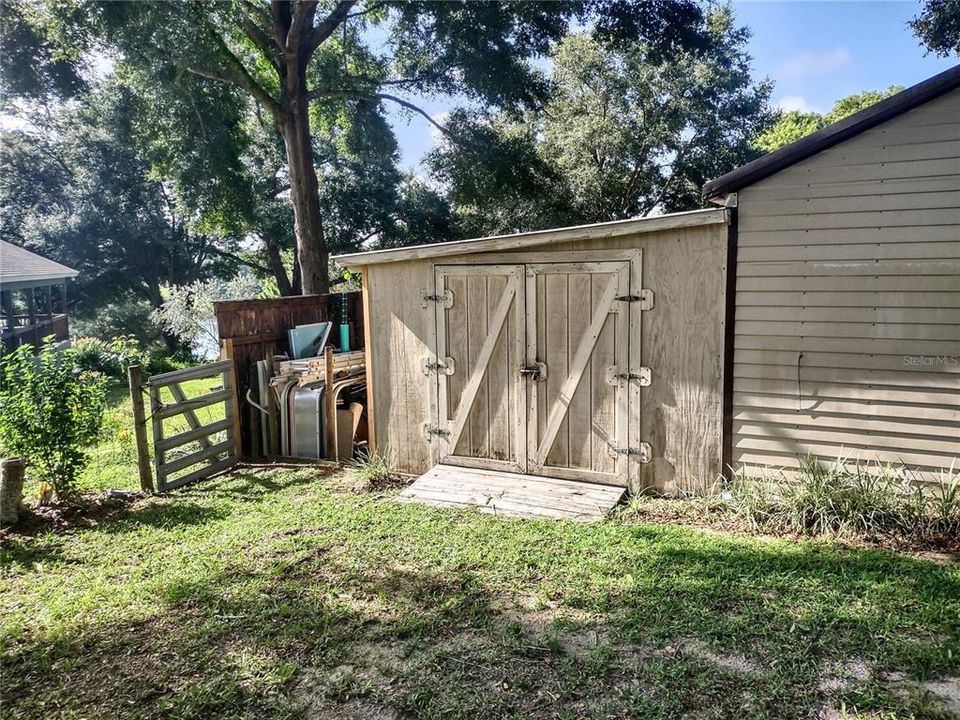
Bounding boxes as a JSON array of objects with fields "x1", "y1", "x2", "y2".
[{"x1": 0, "y1": 240, "x2": 77, "y2": 350}]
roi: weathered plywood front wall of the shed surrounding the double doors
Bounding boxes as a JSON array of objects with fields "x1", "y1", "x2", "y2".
[{"x1": 340, "y1": 210, "x2": 728, "y2": 492}]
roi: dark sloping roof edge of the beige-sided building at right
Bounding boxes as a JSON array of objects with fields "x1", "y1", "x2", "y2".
[{"x1": 703, "y1": 65, "x2": 960, "y2": 203}]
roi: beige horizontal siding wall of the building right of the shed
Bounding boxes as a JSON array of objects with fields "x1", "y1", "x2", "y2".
[{"x1": 732, "y1": 91, "x2": 960, "y2": 480}]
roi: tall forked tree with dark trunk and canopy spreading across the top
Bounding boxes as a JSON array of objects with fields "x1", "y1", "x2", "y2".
[{"x1": 15, "y1": 0, "x2": 705, "y2": 292}]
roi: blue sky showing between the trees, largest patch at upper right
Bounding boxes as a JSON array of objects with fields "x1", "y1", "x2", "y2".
[{"x1": 386, "y1": 0, "x2": 957, "y2": 168}]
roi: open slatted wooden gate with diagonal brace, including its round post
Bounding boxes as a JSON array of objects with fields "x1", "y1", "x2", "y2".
[{"x1": 130, "y1": 360, "x2": 240, "y2": 491}]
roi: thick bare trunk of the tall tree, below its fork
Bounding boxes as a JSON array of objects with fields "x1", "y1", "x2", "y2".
[{"x1": 280, "y1": 95, "x2": 330, "y2": 295}]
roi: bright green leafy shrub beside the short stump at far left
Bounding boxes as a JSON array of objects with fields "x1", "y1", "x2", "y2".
[{"x1": 0, "y1": 340, "x2": 106, "y2": 499}]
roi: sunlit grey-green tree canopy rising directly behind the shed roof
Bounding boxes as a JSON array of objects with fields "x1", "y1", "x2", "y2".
[{"x1": 429, "y1": 8, "x2": 772, "y2": 234}]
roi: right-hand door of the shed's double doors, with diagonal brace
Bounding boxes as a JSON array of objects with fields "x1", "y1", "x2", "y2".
[{"x1": 526, "y1": 262, "x2": 630, "y2": 485}]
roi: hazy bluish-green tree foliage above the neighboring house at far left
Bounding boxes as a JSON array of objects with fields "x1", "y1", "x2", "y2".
[{"x1": 0, "y1": 83, "x2": 226, "y2": 316}]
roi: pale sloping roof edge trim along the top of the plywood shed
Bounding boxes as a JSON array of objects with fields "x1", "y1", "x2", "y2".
[{"x1": 333, "y1": 208, "x2": 729, "y2": 267}]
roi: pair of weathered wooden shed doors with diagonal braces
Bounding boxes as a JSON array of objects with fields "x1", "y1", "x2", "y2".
[{"x1": 428, "y1": 256, "x2": 639, "y2": 485}]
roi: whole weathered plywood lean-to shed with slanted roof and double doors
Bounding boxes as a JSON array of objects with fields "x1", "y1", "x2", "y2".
[{"x1": 336, "y1": 209, "x2": 729, "y2": 492}]
